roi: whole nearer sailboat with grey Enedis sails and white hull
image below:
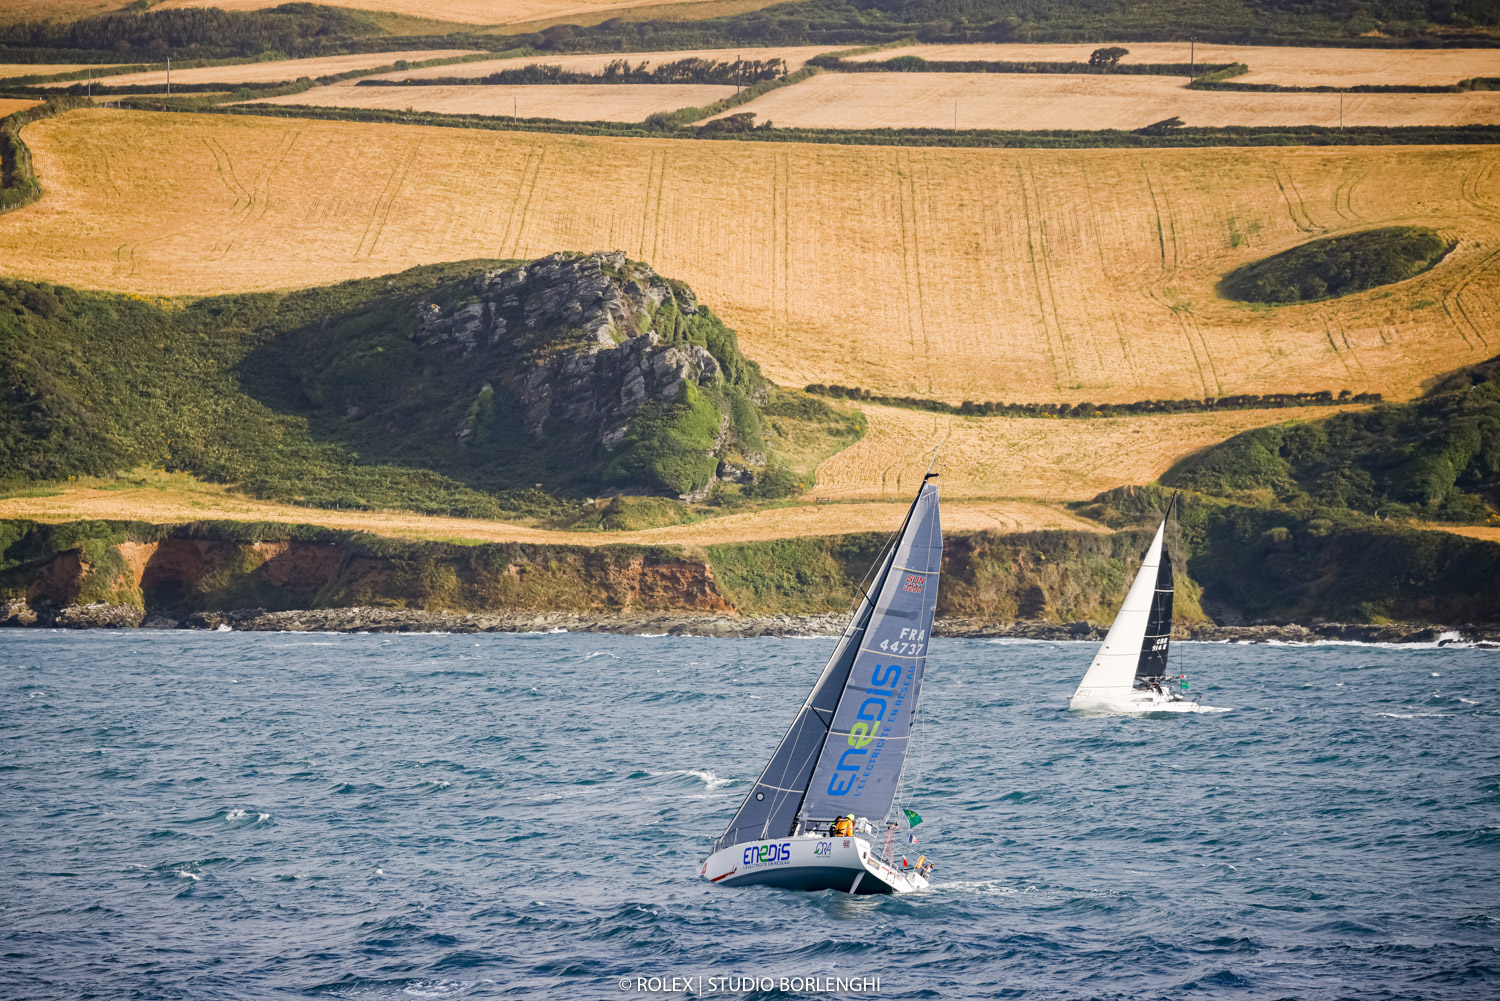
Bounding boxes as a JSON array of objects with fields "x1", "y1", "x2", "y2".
[{"x1": 699, "y1": 473, "x2": 942, "y2": 894}]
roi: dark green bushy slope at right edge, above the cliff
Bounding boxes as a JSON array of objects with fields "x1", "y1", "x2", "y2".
[{"x1": 1163, "y1": 359, "x2": 1500, "y2": 522}]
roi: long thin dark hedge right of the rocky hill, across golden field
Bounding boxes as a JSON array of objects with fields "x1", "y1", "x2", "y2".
[{"x1": 807, "y1": 383, "x2": 1382, "y2": 419}]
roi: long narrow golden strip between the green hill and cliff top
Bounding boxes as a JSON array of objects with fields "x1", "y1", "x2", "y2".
[{"x1": 0, "y1": 483, "x2": 1103, "y2": 546}]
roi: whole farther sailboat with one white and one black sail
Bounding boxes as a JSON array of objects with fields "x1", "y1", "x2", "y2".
[{"x1": 1068, "y1": 494, "x2": 1197, "y2": 713}]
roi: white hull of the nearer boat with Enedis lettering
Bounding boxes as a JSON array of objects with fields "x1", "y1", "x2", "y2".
[{"x1": 699, "y1": 834, "x2": 927, "y2": 896}]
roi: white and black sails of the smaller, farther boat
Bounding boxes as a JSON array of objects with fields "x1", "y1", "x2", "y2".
[{"x1": 1074, "y1": 497, "x2": 1176, "y2": 701}]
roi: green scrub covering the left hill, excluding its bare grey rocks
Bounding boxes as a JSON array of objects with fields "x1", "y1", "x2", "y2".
[{"x1": 0, "y1": 261, "x2": 792, "y2": 519}]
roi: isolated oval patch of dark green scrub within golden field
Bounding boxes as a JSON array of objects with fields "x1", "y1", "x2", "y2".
[{"x1": 1218, "y1": 227, "x2": 1457, "y2": 306}]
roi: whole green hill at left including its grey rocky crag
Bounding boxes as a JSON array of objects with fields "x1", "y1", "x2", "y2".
[{"x1": 0, "y1": 255, "x2": 858, "y2": 516}]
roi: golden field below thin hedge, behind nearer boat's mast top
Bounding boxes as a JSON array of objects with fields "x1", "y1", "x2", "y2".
[{"x1": 813, "y1": 405, "x2": 1340, "y2": 503}]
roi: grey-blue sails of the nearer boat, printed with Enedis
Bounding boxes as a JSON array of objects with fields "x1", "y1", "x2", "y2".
[{"x1": 714, "y1": 473, "x2": 942, "y2": 849}]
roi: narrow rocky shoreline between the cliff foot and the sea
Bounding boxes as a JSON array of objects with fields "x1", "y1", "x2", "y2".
[{"x1": 0, "y1": 600, "x2": 1500, "y2": 648}]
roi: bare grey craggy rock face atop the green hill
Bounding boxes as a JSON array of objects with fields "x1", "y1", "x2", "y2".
[{"x1": 413, "y1": 252, "x2": 722, "y2": 449}]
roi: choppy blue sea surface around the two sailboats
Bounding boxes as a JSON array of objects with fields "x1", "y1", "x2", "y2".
[{"x1": 0, "y1": 630, "x2": 1500, "y2": 1001}]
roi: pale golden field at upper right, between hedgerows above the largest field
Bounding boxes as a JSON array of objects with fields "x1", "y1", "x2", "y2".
[{"x1": 711, "y1": 74, "x2": 1500, "y2": 129}]
